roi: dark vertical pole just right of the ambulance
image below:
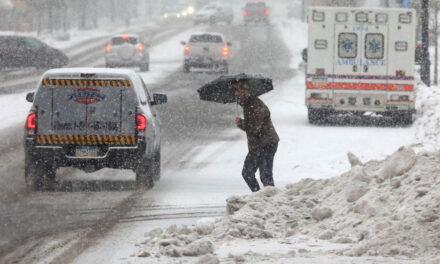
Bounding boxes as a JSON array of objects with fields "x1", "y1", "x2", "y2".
[{"x1": 420, "y1": 0, "x2": 431, "y2": 87}]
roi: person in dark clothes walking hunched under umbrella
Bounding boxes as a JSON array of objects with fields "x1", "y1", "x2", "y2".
[{"x1": 229, "y1": 80, "x2": 280, "y2": 192}]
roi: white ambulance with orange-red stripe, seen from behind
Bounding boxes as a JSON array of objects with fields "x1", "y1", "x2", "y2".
[{"x1": 305, "y1": 7, "x2": 417, "y2": 125}]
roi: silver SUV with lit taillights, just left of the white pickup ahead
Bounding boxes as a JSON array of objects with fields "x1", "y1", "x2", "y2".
[{"x1": 105, "y1": 34, "x2": 150, "y2": 71}]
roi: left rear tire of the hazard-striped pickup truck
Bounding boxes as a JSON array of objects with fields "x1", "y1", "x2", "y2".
[{"x1": 24, "y1": 155, "x2": 57, "y2": 192}]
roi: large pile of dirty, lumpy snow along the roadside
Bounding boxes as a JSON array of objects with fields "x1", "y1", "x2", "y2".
[{"x1": 136, "y1": 147, "x2": 440, "y2": 263}]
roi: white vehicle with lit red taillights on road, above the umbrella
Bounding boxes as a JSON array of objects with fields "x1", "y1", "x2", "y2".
[{"x1": 181, "y1": 33, "x2": 231, "y2": 73}]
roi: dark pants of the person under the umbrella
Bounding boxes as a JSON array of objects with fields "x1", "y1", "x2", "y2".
[{"x1": 242, "y1": 144, "x2": 278, "y2": 192}]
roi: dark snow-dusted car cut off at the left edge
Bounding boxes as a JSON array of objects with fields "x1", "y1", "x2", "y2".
[{"x1": 0, "y1": 35, "x2": 69, "y2": 69}]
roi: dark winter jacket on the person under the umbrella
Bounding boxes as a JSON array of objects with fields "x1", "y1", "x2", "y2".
[{"x1": 238, "y1": 96, "x2": 280, "y2": 152}]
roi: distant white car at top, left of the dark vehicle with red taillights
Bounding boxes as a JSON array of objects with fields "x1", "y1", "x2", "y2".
[{"x1": 194, "y1": 3, "x2": 234, "y2": 25}]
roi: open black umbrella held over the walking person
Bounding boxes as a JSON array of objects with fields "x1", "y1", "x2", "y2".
[{"x1": 197, "y1": 73, "x2": 273, "y2": 104}]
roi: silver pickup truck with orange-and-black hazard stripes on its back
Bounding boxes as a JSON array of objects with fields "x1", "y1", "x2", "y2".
[{"x1": 25, "y1": 68, "x2": 167, "y2": 190}]
